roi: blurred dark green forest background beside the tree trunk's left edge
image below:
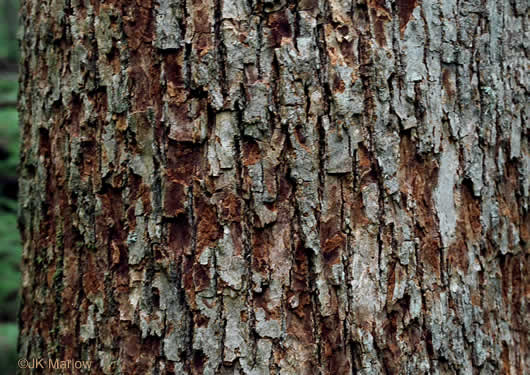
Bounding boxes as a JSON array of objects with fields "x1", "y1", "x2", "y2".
[{"x1": 0, "y1": 0, "x2": 21, "y2": 375}]
